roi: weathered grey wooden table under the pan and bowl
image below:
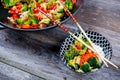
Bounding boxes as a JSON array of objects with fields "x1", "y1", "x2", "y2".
[{"x1": 0, "y1": 0, "x2": 120, "y2": 80}]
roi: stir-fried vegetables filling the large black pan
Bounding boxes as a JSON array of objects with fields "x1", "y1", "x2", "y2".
[{"x1": 1, "y1": 0, "x2": 76, "y2": 29}]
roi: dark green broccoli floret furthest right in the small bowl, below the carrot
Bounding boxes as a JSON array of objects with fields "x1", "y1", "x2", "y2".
[{"x1": 88, "y1": 57, "x2": 101, "y2": 69}]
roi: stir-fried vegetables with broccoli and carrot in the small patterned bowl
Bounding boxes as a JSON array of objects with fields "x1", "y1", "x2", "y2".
[{"x1": 64, "y1": 34, "x2": 101, "y2": 72}]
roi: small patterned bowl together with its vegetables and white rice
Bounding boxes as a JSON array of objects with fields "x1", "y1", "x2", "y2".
[{"x1": 60, "y1": 31, "x2": 112, "y2": 73}]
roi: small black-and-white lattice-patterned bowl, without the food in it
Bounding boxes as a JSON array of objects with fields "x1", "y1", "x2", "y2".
[{"x1": 60, "y1": 31, "x2": 112, "y2": 72}]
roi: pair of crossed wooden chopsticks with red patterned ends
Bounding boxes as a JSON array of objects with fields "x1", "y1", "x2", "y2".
[{"x1": 39, "y1": 1, "x2": 118, "y2": 68}]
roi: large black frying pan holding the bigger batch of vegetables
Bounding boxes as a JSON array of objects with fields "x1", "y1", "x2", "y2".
[{"x1": 0, "y1": 0, "x2": 83, "y2": 31}]
